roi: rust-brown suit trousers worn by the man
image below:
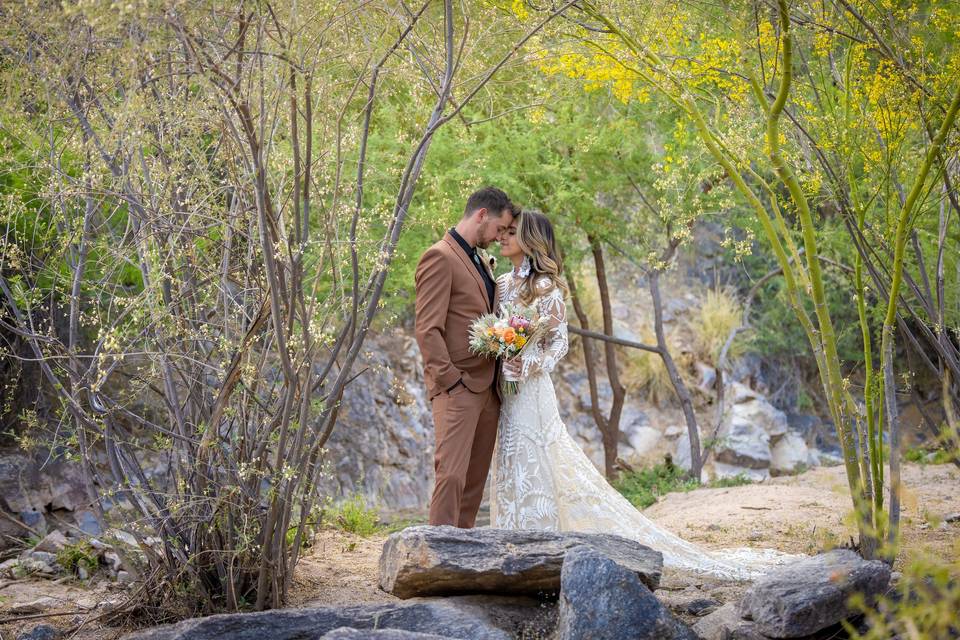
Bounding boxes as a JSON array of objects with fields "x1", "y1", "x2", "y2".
[{"x1": 430, "y1": 384, "x2": 500, "y2": 529}]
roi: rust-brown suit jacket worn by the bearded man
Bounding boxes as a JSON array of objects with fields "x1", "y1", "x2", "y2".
[{"x1": 416, "y1": 233, "x2": 497, "y2": 398}]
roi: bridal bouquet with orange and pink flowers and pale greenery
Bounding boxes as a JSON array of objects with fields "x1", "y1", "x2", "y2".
[{"x1": 470, "y1": 304, "x2": 542, "y2": 393}]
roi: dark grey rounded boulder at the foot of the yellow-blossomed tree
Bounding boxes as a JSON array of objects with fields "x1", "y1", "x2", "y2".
[{"x1": 740, "y1": 549, "x2": 890, "y2": 638}]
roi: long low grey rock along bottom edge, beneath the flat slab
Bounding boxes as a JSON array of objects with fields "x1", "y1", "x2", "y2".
[{"x1": 126, "y1": 596, "x2": 539, "y2": 640}]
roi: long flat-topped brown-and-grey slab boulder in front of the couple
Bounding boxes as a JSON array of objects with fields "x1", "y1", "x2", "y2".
[{"x1": 380, "y1": 526, "x2": 663, "y2": 598}]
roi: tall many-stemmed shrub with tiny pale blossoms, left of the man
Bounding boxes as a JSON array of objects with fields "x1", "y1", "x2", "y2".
[{"x1": 0, "y1": 2, "x2": 528, "y2": 622}]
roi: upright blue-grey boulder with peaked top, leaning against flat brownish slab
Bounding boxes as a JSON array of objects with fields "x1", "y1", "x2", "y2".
[{"x1": 556, "y1": 547, "x2": 696, "y2": 640}]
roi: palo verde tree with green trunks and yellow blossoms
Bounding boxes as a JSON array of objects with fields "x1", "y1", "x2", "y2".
[{"x1": 524, "y1": 0, "x2": 960, "y2": 556}]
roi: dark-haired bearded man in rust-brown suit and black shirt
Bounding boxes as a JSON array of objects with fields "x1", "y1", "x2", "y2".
[{"x1": 416, "y1": 187, "x2": 513, "y2": 529}]
